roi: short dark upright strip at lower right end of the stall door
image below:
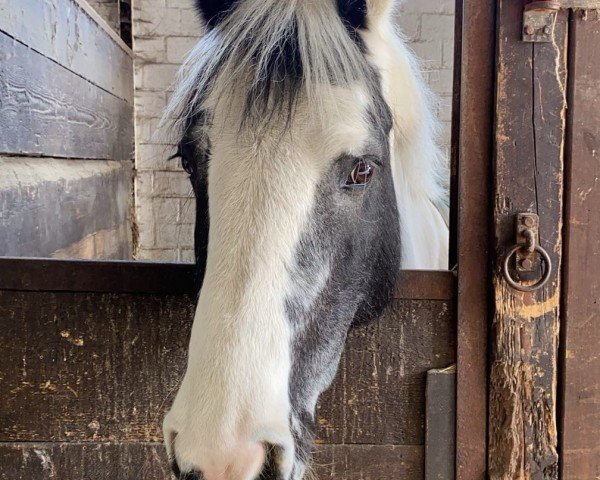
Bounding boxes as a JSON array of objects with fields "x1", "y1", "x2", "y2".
[{"x1": 425, "y1": 365, "x2": 456, "y2": 480}]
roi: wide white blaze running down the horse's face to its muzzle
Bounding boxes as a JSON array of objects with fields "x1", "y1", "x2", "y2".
[{"x1": 165, "y1": 87, "x2": 371, "y2": 480}]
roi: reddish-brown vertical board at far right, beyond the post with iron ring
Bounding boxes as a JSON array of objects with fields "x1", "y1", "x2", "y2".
[{"x1": 561, "y1": 12, "x2": 600, "y2": 480}]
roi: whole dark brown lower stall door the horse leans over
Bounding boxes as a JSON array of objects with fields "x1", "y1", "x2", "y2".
[{"x1": 0, "y1": 258, "x2": 456, "y2": 480}]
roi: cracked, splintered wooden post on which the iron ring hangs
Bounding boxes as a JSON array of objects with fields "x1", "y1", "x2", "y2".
[{"x1": 488, "y1": 0, "x2": 567, "y2": 480}]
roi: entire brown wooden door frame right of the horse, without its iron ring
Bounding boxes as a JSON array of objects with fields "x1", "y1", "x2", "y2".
[{"x1": 452, "y1": 0, "x2": 600, "y2": 480}]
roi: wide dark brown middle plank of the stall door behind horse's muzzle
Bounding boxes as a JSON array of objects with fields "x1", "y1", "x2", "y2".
[{"x1": 0, "y1": 291, "x2": 455, "y2": 444}]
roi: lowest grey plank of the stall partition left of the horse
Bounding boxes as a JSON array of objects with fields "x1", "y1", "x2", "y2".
[{"x1": 0, "y1": 156, "x2": 131, "y2": 258}]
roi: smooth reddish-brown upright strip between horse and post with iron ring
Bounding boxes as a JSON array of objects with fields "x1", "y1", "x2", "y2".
[{"x1": 453, "y1": 0, "x2": 496, "y2": 480}]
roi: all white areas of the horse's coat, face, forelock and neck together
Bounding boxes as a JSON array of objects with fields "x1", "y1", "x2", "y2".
[{"x1": 165, "y1": 0, "x2": 447, "y2": 480}]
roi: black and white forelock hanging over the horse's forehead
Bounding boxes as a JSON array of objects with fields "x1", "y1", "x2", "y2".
[{"x1": 165, "y1": 0, "x2": 379, "y2": 141}]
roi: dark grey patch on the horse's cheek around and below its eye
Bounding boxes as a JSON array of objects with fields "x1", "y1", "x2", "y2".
[{"x1": 285, "y1": 94, "x2": 400, "y2": 472}]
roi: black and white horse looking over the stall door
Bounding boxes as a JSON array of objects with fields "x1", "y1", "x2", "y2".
[{"x1": 163, "y1": 0, "x2": 448, "y2": 480}]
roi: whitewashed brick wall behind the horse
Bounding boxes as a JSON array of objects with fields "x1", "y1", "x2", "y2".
[{"x1": 132, "y1": 0, "x2": 454, "y2": 261}]
